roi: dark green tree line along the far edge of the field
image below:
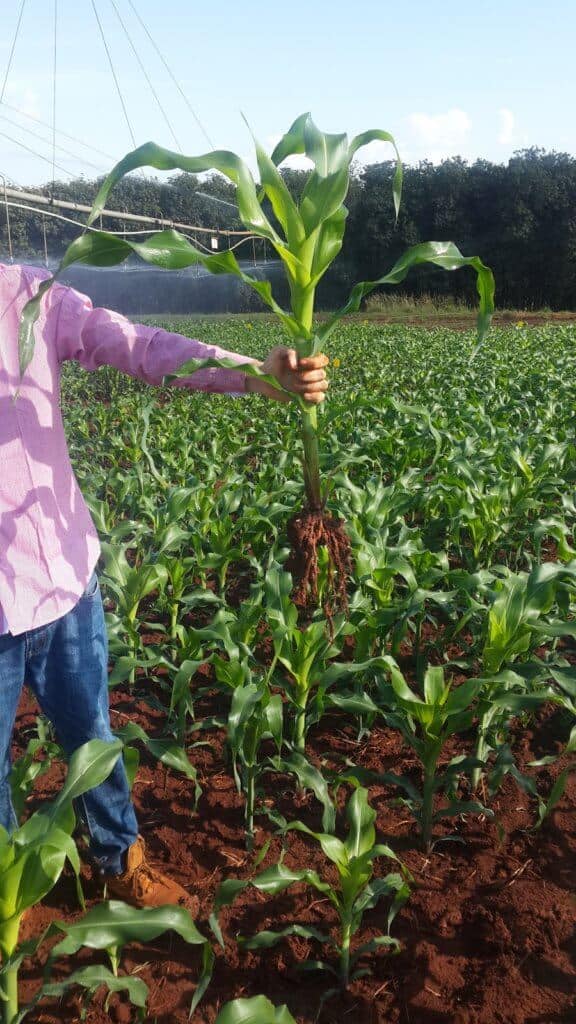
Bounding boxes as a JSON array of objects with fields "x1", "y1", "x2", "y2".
[{"x1": 0, "y1": 148, "x2": 576, "y2": 309}]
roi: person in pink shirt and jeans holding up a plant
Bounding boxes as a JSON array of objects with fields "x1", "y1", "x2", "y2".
[{"x1": 0, "y1": 263, "x2": 328, "y2": 908}]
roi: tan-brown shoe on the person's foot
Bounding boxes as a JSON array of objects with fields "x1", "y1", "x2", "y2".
[{"x1": 104, "y1": 836, "x2": 199, "y2": 918}]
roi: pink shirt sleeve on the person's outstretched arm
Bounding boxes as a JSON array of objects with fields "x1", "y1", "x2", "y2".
[{"x1": 56, "y1": 287, "x2": 252, "y2": 394}]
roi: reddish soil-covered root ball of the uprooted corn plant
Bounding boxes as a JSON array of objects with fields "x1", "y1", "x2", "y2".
[{"x1": 286, "y1": 508, "x2": 353, "y2": 622}]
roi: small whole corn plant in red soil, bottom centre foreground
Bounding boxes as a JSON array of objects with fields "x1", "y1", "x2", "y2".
[{"x1": 210, "y1": 787, "x2": 410, "y2": 988}]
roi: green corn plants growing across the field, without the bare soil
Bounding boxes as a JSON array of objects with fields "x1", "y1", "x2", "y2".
[{"x1": 5, "y1": 319, "x2": 576, "y2": 1024}]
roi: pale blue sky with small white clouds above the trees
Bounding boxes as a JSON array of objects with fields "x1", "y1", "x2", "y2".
[{"x1": 0, "y1": 0, "x2": 576, "y2": 184}]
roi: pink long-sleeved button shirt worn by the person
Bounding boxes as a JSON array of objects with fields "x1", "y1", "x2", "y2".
[{"x1": 0, "y1": 263, "x2": 252, "y2": 635}]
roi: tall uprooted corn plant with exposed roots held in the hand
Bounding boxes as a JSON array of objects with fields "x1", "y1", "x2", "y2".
[{"x1": 20, "y1": 114, "x2": 494, "y2": 606}]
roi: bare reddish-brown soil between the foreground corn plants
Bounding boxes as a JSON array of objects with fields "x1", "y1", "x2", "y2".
[{"x1": 14, "y1": 680, "x2": 576, "y2": 1024}]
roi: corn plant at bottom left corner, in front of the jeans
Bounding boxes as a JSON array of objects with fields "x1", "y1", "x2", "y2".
[{"x1": 0, "y1": 739, "x2": 122, "y2": 1024}]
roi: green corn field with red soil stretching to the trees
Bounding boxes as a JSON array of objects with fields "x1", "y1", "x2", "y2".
[{"x1": 13, "y1": 317, "x2": 576, "y2": 1024}]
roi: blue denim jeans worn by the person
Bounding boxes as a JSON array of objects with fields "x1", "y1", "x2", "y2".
[{"x1": 0, "y1": 573, "x2": 138, "y2": 873}]
